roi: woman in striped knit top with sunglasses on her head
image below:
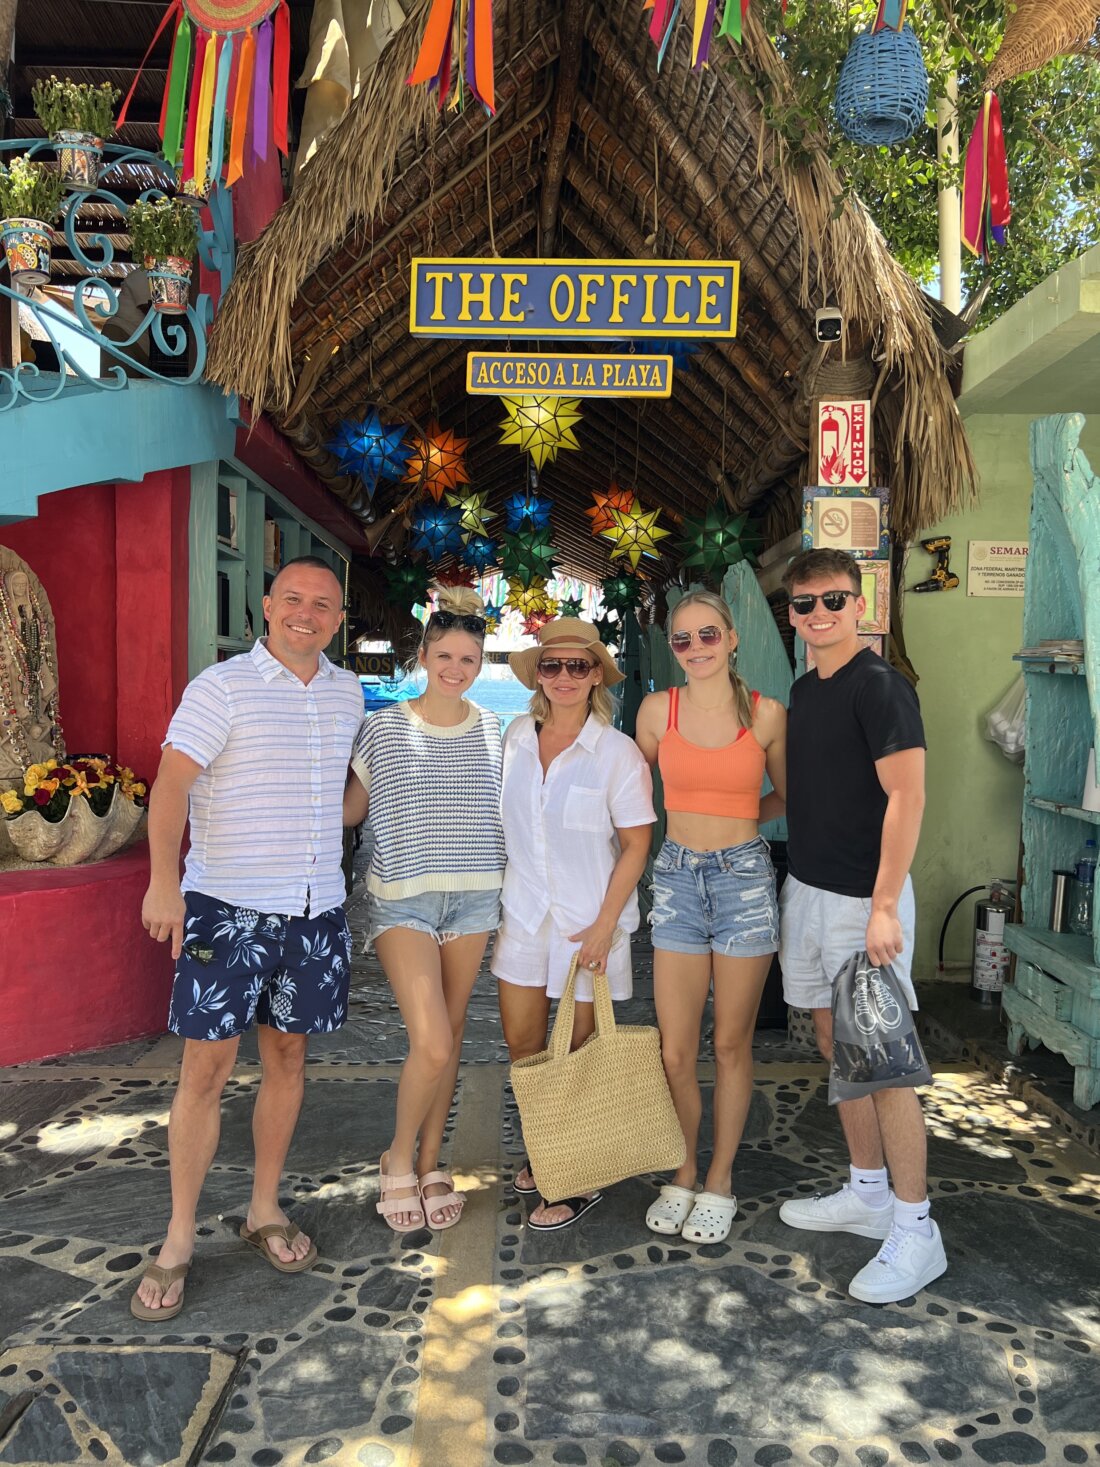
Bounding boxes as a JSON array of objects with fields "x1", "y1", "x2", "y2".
[{"x1": 345, "y1": 587, "x2": 505, "y2": 1232}]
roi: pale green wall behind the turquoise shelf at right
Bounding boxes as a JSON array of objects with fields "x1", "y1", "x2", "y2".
[{"x1": 905, "y1": 414, "x2": 1100, "y2": 978}]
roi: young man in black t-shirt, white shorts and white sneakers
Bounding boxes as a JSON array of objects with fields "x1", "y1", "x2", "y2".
[{"x1": 779, "y1": 550, "x2": 947, "y2": 1304}]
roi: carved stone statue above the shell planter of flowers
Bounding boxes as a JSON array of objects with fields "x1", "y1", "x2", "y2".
[{"x1": 0, "y1": 546, "x2": 65, "y2": 789}]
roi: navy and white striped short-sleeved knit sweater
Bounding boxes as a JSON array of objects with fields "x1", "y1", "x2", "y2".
[{"x1": 352, "y1": 703, "x2": 505, "y2": 899}]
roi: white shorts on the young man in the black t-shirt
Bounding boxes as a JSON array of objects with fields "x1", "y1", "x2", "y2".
[{"x1": 779, "y1": 876, "x2": 917, "y2": 1009}]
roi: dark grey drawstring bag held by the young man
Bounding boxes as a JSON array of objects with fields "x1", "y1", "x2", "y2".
[{"x1": 829, "y1": 952, "x2": 931, "y2": 1105}]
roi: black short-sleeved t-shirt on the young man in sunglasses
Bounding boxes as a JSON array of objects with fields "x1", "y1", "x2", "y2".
[{"x1": 786, "y1": 647, "x2": 925, "y2": 896}]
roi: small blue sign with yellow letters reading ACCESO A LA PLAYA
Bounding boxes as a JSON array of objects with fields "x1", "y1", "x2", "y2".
[{"x1": 466, "y1": 352, "x2": 672, "y2": 398}]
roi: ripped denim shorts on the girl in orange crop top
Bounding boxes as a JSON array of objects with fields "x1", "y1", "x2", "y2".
[{"x1": 650, "y1": 836, "x2": 779, "y2": 958}]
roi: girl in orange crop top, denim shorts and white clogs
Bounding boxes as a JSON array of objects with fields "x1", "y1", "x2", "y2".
[{"x1": 637, "y1": 591, "x2": 786, "y2": 1243}]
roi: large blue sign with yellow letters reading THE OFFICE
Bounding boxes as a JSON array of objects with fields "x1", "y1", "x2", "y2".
[{"x1": 409, "y1": 258, "x2": 739, "y2": 340}]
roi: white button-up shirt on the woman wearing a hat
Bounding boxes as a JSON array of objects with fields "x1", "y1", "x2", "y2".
[{"x1": 500, "y1": 714, "x2": 657, "y2": 934}]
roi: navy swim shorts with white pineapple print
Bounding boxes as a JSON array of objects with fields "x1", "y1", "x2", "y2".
[{"x1": 169, "y1": 892, "x2": 352, "y2": 1039}]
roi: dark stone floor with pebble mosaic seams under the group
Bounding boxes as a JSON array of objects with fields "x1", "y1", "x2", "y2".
[{"x1": 0, "y1": 891, "x2": 1100, "y2": 1467}]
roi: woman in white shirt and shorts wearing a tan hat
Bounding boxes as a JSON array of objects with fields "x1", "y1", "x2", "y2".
[{"x1": 491, "y1": 616, "x2": 657, "y2": 1232}]
